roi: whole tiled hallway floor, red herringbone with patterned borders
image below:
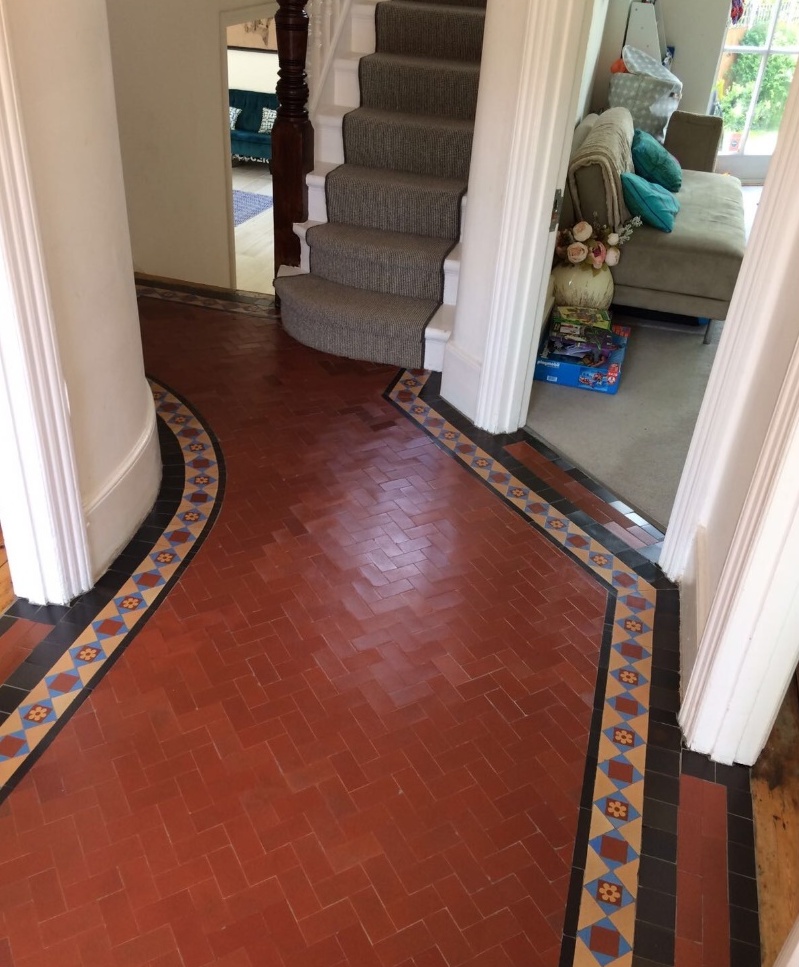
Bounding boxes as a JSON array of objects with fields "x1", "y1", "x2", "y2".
[{"x1": 0, "y1": 290, "x2": 759, "y2": 967}]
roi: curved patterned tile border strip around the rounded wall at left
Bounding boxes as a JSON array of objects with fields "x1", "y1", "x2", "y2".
[{"x1": 0, "y1": 380, "x2": 224, "y2": 799}]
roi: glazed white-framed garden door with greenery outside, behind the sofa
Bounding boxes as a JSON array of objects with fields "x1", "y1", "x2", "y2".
[{"x1": 712, "y1": 0, "x2": 799, "y2": 185}]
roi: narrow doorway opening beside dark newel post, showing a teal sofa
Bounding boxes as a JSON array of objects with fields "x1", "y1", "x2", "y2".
[{"x1": 225, "y1": 17, "x2": 278, "y2": 295}]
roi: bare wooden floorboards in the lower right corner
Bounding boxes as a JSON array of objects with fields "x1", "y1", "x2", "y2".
[{"x1": 752, "y1": 682, "x2": 799, "y2": 967}]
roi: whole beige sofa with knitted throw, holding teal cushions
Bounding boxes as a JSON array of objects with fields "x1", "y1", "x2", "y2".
[{"x1": 561, "y1": 107, "x2": 746, "y2": 319}]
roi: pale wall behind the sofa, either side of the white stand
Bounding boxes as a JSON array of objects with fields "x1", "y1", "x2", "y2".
[{"x1": 590, "y1": 0, "x2": 730, "y2": 114}]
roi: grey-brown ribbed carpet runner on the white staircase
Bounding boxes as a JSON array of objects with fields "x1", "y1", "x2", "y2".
[{"x1": 275, "y1": 0, "x2": 486, "y2": 369}]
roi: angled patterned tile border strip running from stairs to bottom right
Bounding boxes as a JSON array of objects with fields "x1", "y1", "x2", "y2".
[{"x1": 388, "y1": 372, "x2": 657, "y2": 967}]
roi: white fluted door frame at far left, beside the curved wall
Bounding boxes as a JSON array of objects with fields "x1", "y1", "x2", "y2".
[{"x1": 0, "y1": 0, "x2": 92, "y2": 604}]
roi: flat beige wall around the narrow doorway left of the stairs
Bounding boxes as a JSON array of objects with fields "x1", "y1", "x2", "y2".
[{"x1": 108, "y1": 0, "x2": 276, "y2": 287}]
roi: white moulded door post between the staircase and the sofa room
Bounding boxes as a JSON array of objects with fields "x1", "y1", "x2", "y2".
[{"x1": 442, "y1": 0, "x2": 591, "y2": 432}]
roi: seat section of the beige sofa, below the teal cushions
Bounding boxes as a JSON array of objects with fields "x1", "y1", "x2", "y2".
[{"x1": 613, "y1": 170, "x2": 746, "y2": 302}]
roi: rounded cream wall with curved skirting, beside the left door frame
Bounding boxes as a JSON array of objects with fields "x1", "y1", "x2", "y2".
[{"x1": 6, "y1": 0, "x2": 160, "y2": 576}]
